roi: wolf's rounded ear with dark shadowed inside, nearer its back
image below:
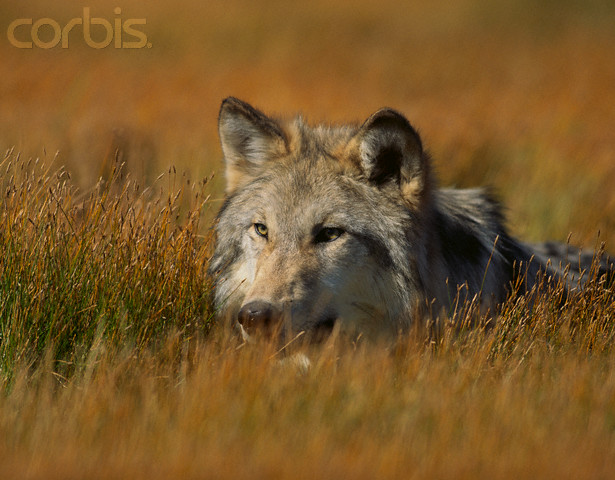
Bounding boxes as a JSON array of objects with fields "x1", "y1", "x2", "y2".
[{"x1": 351, "y1": 108, "x2": 429, "y2": 203}]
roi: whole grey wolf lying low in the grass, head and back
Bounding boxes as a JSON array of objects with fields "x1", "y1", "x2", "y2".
[{"x1": 209, "y1": 97, "x2": 606, "y2": 338}]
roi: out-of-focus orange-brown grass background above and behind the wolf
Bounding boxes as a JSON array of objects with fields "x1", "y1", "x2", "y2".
[{"x1": 0, "y1": 0, "x2": 615, "y2": 242}]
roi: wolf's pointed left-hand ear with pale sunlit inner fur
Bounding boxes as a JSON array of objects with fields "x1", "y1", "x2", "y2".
[{"x1": 218, "y1": 97, "x2": 288, "y2": 193}]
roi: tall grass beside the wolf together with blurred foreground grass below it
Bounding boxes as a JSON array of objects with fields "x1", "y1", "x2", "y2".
[{"x1": 0, "y1": 152, "x2": 615, "y2": 479}]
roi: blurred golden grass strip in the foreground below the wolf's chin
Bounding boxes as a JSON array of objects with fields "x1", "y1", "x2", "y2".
[{"x1": 0, "y1": 320, "x2": 615, "y2": 479}]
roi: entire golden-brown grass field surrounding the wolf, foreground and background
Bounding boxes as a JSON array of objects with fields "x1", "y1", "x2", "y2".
[{"x1": 0, "y1": 0, "x2": 615, "y2": 479}]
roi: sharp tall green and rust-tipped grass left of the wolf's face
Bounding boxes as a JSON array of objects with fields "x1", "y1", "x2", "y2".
[{"x1": 0, "y1": 151, "x2": 211, "y2": 374}]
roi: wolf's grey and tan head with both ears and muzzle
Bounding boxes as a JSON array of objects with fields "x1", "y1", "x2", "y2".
[{"x1": 210, "y1": 98, "x2": 431, "y2": 337}]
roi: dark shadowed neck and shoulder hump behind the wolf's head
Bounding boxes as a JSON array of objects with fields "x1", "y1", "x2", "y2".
[{"x1": 418, "y1": 189, "x2": 529, "y2": 314}]
